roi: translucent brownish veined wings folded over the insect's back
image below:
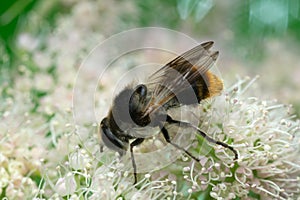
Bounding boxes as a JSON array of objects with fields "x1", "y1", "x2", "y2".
[{"x1": 144, "y1": 41, "x2": 219, "y2": 115}]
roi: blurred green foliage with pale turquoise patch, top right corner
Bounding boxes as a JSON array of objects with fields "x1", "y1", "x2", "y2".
[{"x1": 231, "y1": 0, "x2": 300, "y2": 61}]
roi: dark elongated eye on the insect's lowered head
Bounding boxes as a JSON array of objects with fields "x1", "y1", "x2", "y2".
[{"x1": 100, "y1": 118, "x2": 126, "y2": 152}]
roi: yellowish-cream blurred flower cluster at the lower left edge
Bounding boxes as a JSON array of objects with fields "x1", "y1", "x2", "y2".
[{"x1": 0, "y1": 95, "x2": 47, "y2": 199}]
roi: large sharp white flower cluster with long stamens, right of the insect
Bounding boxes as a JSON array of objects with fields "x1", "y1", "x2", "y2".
[{"x1": 177, "y1": 76, "x2": 300, "y2": 199}]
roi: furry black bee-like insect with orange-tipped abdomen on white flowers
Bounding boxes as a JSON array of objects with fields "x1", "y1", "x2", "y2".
[{"x1": 100, "y1": 41, "x2": 238, "y2": 184}]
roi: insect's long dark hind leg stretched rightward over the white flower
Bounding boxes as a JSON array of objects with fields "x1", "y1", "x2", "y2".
[{"x1": 167, "y1": 115, "x2": 238, "y2": 160}]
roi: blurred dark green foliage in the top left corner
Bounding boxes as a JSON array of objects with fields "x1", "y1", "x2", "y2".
[{"x1": 0, "y1": 0, "x2": 68, "y2": 80}]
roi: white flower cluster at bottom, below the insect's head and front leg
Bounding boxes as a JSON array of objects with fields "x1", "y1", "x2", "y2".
[{"x1": 38, "y1": 143, "x2": 177, "y2": 200}]
